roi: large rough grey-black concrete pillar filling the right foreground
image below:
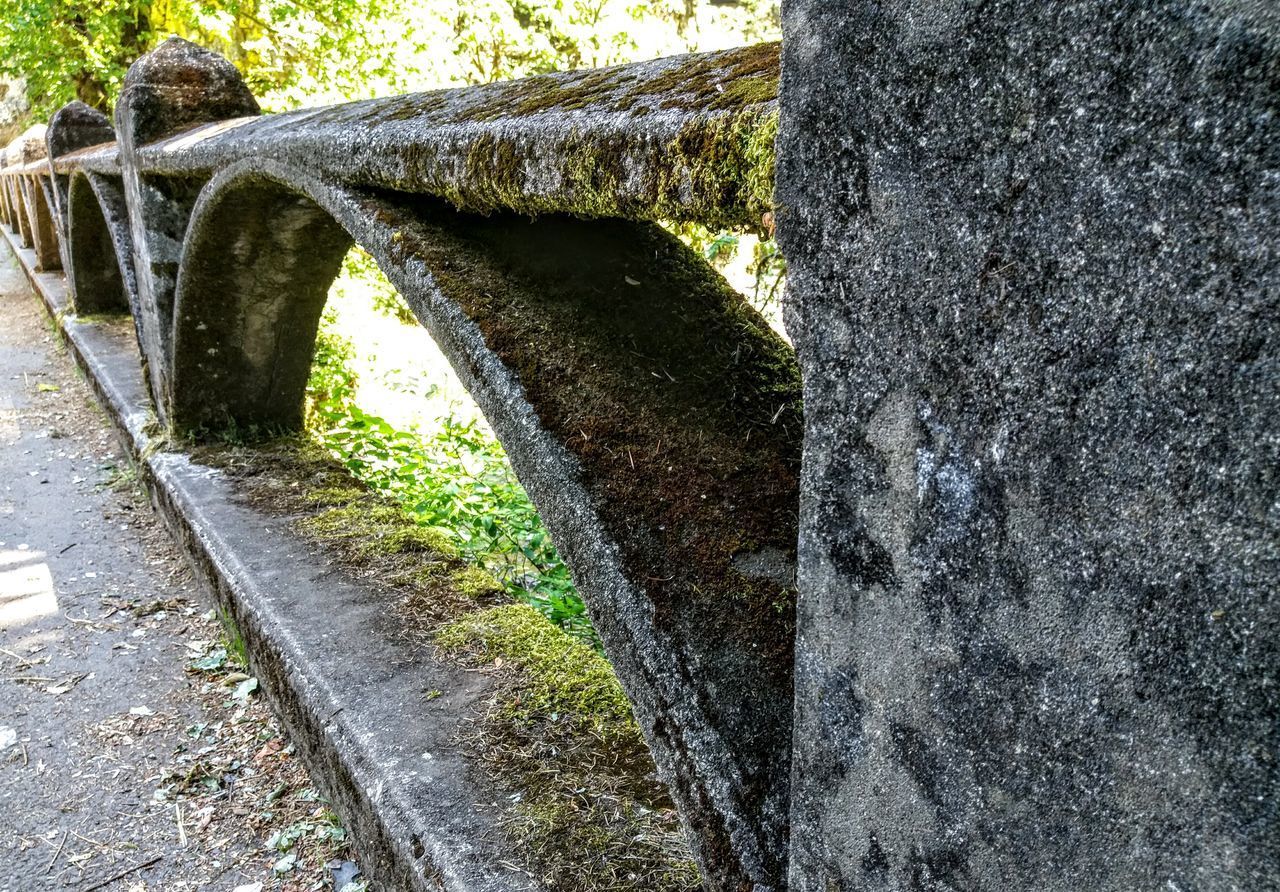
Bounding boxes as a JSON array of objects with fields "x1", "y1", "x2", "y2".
[{"x1": 777, "y1": 0, "x2": 1280, "y2": 892}]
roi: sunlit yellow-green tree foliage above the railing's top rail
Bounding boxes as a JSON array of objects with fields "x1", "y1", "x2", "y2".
[{"x1": 0, "y1": 0, "x2": 778, "y2": 118}]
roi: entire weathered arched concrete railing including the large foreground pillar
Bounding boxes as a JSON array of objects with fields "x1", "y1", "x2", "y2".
[{"x1": 3, "y1": 0, "x2": 1280, "y2": 892}]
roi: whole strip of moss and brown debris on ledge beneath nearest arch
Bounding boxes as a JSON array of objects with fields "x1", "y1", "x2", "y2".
[{"x1": 195, "y1": 436, "x2": 700, "y2": 892}]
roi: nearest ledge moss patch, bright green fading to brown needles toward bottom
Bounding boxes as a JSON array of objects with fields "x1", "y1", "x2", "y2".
[{"x1": 436, "y1": 604, "x2": 700, "y2": 892}]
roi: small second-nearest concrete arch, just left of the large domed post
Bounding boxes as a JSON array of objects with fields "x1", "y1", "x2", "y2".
[{"x1": 67, "y1": 171, "x2": 138, "y2": 314}]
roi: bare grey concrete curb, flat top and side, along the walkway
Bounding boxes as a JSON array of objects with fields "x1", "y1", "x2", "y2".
[{"x1": 3, "y1": 229, "x2": 540, "y2": 892}]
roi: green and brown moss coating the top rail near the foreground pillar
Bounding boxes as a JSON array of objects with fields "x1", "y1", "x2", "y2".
[{"x1": 422, "y1": 44, "x2": 778, "y2": 227}]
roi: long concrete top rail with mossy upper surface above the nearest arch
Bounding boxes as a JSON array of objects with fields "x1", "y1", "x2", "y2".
[{"x1": 58, "y1": 44, "x2": 778, "y2": 225}]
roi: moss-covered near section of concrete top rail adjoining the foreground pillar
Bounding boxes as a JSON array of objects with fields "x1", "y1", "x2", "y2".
[{"x1": 381, "y1": 44, "x2": 778, "y2": 227}]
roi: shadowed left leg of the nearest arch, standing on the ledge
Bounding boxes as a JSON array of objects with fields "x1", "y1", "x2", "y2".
[{"x1": 170, "y1": 180, "x2": 352, "y2": 436}]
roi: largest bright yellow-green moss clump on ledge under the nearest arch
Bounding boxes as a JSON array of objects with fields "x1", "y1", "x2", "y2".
[{"x1": 435, "y1": 604, "x2": 629, "y2": 738}]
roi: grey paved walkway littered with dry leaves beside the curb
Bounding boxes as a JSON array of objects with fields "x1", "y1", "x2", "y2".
[{"x1": 0, "y1": 244, "x2": 355, "y2": 892}]
